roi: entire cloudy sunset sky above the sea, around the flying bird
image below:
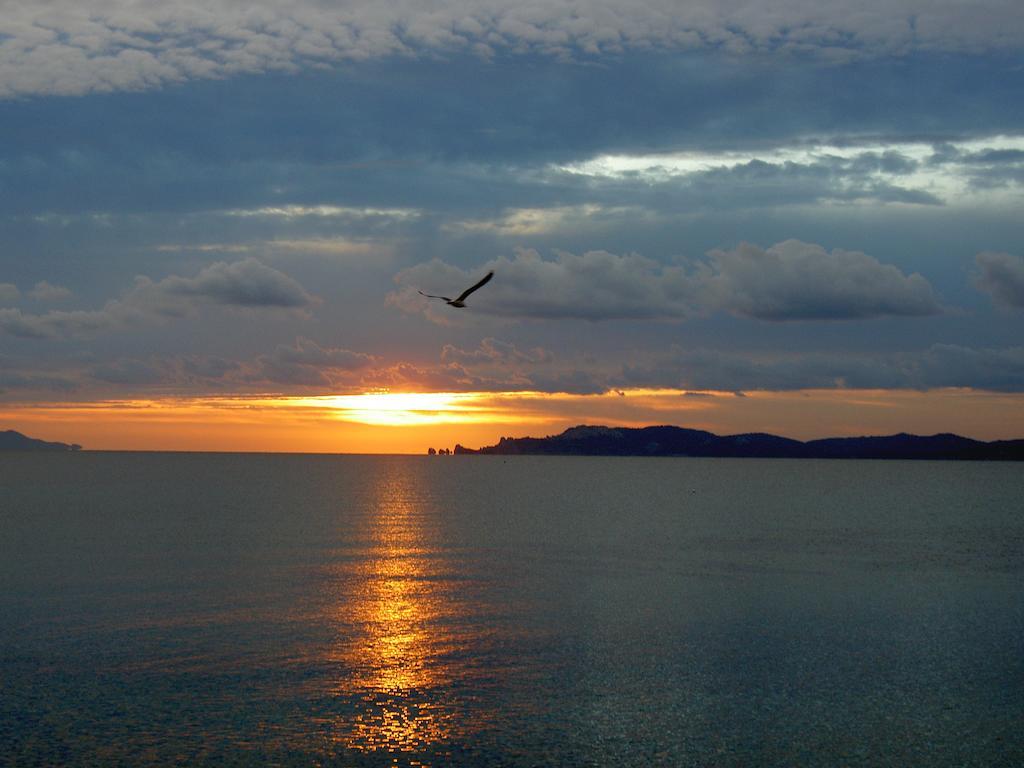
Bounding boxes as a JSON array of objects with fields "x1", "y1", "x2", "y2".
[{"x1": 0, "y1": 0, "x2": 1024, "y2": 453}]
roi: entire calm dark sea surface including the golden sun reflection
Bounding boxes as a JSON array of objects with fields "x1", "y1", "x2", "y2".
[{"x1": 0, "y1": 453, "x2": 1024, "y2": 766}]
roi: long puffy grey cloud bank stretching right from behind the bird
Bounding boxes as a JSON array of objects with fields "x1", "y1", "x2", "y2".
[{"x1": 388, "y1": 240, "x2": 941, "y2": 322}]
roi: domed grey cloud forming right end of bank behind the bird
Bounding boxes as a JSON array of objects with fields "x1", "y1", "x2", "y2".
[{"x1": 701, "y1": 240, "x2": 941, "y2": 321}]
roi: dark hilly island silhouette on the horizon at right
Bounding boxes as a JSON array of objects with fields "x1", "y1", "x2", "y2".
[{"x1": 455, "y1": 426, "x2": 1024, "y2": 461}]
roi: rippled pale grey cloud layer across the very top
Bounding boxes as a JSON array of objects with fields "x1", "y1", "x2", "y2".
[{"x1": 0, "y1": 0, "x2": 1024, "y2": 97}]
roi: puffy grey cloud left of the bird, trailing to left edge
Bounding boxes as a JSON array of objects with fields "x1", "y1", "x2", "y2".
[{"x1": 0, "y1": 258, "x2": 317, "y2": 339}]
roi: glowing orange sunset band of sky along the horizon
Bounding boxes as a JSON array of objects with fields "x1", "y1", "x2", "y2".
[{"x1": 0, "y1": 389, "x2": 1024, "y2": 454}]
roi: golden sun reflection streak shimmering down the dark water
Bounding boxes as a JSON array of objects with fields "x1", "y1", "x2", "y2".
[{"x1": 333, "y1": 467, "x2": 464, "y2": 753}]
